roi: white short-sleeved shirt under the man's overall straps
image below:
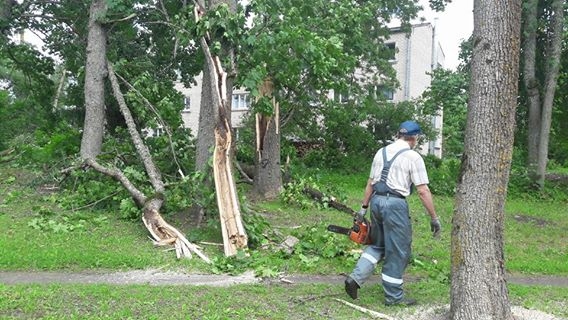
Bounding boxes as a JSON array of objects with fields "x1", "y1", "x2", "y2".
[{"x1": 369, "y1": 139, "x2": 429, "y2": 197}]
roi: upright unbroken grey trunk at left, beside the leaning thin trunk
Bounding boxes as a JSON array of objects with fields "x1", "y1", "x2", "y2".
[{"x1": 81, "y1": 0, "x2": 106, "y2": 159}]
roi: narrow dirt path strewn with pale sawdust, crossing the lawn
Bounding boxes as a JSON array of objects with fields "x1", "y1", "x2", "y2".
[{"x1": 0, "y1": 270, "x2": 568, "y2": 287}]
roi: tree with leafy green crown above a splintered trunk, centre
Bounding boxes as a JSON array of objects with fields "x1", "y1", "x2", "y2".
[{"x1": 237, "y1": 0, "x2": 428, "y2": 198}]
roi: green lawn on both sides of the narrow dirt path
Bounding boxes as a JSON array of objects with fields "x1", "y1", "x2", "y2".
[{"x1": 0, "y1": 167, "x2": 568, "y2": 319}]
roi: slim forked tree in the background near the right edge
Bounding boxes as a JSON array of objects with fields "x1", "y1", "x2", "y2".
[{"x1": 523, "y1": 0, "x2": 566, "y2": 188}]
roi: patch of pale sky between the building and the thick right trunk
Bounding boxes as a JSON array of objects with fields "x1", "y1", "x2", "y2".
[{"x1": 419, "y1": 0, "x2": 473, "y2": 70}]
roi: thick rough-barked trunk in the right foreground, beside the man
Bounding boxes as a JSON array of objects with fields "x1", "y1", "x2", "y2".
[{"x1": 450, "y1": 0, "x2": 521, "y2": 320}]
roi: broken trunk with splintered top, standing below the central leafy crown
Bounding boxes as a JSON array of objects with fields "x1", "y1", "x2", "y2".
[{"x1": 253, "y1": 80, "x2": 282, "y2": 200}]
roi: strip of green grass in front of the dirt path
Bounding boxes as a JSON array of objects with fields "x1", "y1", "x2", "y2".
[{"x1": 0, "y1": 281, "x2": 568, "y2": 319}]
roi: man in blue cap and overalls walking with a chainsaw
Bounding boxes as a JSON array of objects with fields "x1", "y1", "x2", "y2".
[{"x1": 345, "y1": 121, "x2": 441, "y2": 306}]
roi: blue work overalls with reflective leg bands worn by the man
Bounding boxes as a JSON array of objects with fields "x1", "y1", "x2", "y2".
[{"x1": 350, "y1": 148, "x2": 412, "y2": 303}]
